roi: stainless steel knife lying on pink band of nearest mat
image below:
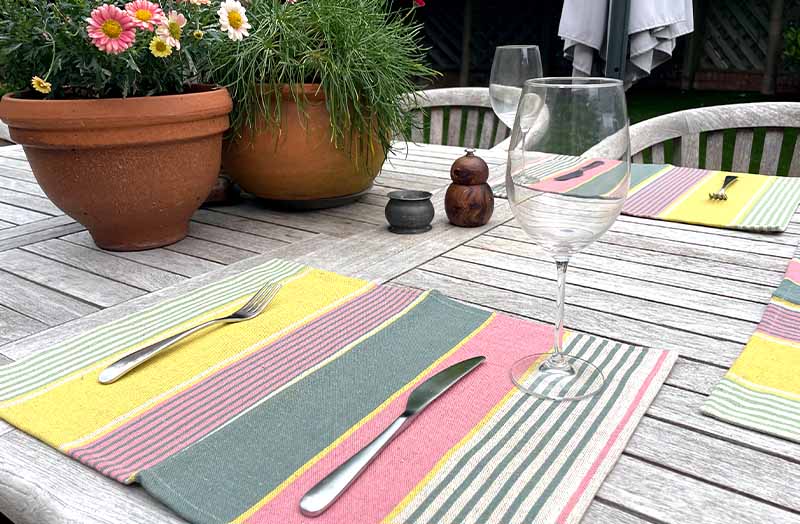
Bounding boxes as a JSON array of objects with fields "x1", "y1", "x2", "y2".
[{"x1": 300, "y1": 356, "x2": 486, "y2": 517}]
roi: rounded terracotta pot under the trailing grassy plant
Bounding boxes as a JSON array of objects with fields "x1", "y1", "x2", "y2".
[{"x1": 222, "y1": 84, "x2": 384, "y2": 208}]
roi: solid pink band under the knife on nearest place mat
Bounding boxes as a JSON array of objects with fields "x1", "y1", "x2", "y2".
[{"x1": 241, "y1": 315, "x2": 552, "y2": 524}]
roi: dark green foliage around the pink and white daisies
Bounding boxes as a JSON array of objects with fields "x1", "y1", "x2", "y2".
[{"x1": 0, "y1": 0, "x2": 222, "y2": 99}]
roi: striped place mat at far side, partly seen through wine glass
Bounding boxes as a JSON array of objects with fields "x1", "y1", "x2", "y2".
[{"x1": 494, "y1": 155, "x2": 800, "y2": 233}]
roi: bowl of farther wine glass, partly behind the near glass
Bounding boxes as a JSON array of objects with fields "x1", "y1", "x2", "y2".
[{"x1": 489, "y1": 45, "x2": 542, "y2": 128}]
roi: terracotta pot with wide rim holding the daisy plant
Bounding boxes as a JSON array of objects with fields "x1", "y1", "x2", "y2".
[{"x1": 0, "y1": 87, "x2": 232, "y2": 251}]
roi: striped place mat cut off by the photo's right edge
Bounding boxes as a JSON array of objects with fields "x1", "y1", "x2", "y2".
[{"x1": 701, "y1": 249, "x2": 800, "y2": 442}]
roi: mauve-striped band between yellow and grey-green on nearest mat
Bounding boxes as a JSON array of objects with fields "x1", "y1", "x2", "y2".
[{"x1": 69, "y1": 286, "x2": 420, "y2": 482}]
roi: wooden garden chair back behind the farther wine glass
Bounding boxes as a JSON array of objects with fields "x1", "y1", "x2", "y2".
[{"x1": 409, "y1": 87, "x2": 510, "y2": 149}]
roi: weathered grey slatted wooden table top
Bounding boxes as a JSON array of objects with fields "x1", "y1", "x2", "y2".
[{"x1": 0, "y1": 145, "x2": 800, "y2": 524}]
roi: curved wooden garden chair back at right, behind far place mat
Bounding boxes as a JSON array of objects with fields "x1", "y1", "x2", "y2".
[{"x1": 630, "y1": 102, "x2": 800, "y2": 176}]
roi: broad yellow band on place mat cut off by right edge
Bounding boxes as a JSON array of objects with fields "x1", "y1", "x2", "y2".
[{"x1": 730, "y1": 333, "x2": 800, "y2": 400}]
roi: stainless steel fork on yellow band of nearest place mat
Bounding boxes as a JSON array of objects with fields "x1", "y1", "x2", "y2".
[{"x1": 97, "y1": 284, "x2": 281, "y2": 384}]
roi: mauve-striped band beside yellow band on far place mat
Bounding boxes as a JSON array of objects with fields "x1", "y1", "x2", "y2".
[{"x1": 622, "y1": 167, "x2": 711, "y2": 217}]
